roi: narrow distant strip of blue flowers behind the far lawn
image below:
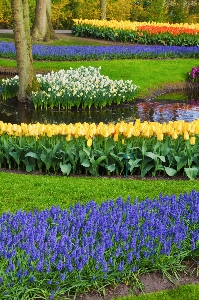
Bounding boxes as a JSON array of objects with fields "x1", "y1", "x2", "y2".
[{"x1": 0, "y1": 42, "x2": 199, "y2": 61}]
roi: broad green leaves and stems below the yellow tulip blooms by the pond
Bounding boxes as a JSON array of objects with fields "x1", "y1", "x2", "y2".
[{"x1": 0, "y1": 133, "x2": 199, "y2": 179}]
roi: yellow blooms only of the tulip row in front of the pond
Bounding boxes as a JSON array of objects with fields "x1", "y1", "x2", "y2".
[{"x1": 0, "y1": 119, "x2": 199, "y2": 144}]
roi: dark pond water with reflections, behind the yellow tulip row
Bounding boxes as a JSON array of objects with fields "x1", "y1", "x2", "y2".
[{"x1": 0, "y1": 76, "x2": 199, "y2": 124}]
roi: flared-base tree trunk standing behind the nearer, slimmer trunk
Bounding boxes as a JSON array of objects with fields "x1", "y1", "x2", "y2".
[{"x1": 31, "y1": 0, "x2": 58, "y2": 41}]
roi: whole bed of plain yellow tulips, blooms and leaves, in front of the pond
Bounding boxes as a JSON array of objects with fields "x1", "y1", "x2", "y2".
[{"x1": 0, "y1": 120, "x2": 199, "y2": 179}]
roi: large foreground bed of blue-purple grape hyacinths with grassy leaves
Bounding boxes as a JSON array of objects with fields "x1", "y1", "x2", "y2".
[{"x1": 0, "y1": 190, "x2": 199, "y2": 299}]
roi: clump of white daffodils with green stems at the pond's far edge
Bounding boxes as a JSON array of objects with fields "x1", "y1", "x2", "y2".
[{"x1": 0, "y1": 67, "x2": 139, "y2": 109}]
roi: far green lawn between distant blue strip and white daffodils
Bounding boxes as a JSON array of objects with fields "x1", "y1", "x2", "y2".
[{"x1": 0, "y1": 59, "x2": 198, "y2": 97}]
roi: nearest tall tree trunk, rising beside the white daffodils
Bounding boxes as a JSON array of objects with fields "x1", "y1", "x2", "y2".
[{"x1": 11, "y1": 0, "x2": 35, "y2": 102}]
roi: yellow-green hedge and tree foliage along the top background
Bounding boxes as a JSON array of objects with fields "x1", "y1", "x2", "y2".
[{"x1": 0, "y1": 0, "x2": 199, "y2": 29}]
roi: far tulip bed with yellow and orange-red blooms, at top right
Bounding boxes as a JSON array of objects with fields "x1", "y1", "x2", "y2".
[{"x1": 72, "y1": 19, "x2": 199, "y2": 46}]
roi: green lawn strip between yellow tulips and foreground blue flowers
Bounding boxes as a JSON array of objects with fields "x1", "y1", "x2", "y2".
[{"x1": 0, "y1": 172, "x2": 199, "y2": 213}]
